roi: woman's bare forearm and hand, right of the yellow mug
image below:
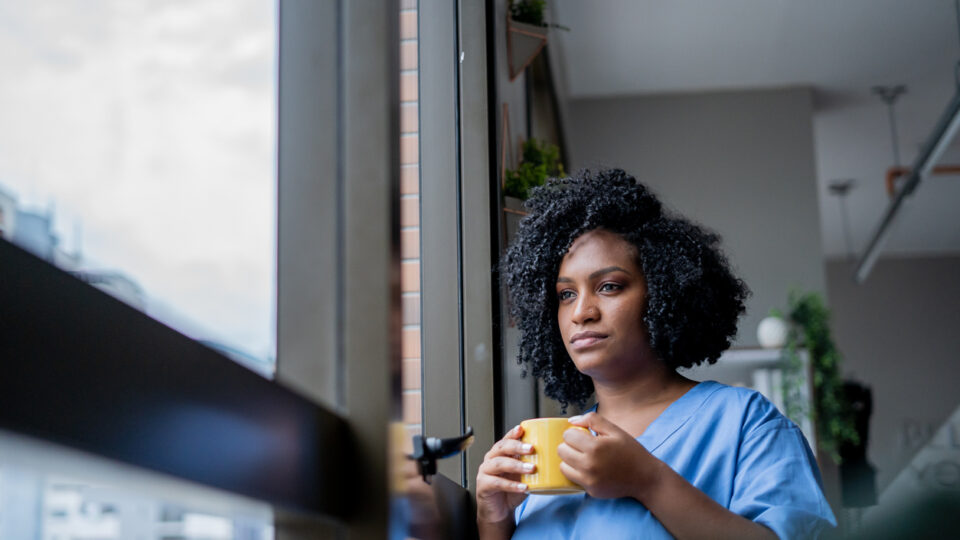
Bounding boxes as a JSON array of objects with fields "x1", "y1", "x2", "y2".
[{"x1": 557, "y1": 413, "x2": 777, "y2": 539}]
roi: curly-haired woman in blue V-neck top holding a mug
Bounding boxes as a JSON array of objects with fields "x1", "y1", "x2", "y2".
[{"x1": 477, "y1": 170, "x2": 835, "y2": 540}]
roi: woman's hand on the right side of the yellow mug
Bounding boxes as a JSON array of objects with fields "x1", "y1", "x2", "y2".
[{"x1": 557, "y1": 412, "x2": 662, "y2": 500}]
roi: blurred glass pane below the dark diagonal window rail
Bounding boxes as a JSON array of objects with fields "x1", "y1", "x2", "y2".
[{"x1": 0, "y1": 432, "x2": 274, "y2": 540}]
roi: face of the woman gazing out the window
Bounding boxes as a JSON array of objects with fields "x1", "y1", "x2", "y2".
[{"x1": 557, "y1": 229, "x2": 654, "y2": 380}]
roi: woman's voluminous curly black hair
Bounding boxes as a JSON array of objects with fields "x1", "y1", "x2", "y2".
[{"x1": 500, "y1": 169, "x2": 750, "y2": 409}]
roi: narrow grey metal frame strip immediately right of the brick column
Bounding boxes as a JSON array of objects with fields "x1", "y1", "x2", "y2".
[{"x1": 417, "y1": 0, "x2": 466, "y2": 485}]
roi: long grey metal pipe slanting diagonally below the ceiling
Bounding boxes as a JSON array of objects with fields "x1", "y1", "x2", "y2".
[{"x1": 853, "y1": 90, "x2": 960, "y2": 283}]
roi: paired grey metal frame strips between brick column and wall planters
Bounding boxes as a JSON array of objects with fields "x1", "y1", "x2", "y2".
[{"x1": 418, "y1": 0, "x2": 500, "y2": 490}]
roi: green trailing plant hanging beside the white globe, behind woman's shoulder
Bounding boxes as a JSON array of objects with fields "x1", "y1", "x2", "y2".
[{"x1": 783, "y1": 291, "x2": 860, "y2": 463}]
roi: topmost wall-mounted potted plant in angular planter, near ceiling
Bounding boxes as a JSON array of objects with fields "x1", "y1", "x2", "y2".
[{"x1": 507, "y1": 0, "x2": 569, "y2": 81}]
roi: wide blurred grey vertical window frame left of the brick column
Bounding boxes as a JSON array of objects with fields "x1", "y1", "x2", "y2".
[{"x1": 277, "y1": 0, "x2": 402, "y2": 538}]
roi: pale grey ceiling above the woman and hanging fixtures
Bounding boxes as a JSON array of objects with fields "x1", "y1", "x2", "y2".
[{"x1": 550, "y1": 0, "x2": 960, "y2": 257}]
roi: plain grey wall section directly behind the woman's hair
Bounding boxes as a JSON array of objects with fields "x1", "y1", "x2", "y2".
[{"x1": 567, "y1": 88, "x2": 825, "y2": 346}]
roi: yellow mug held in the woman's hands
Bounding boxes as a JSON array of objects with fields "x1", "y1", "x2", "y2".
[{"x1": 520, "y1": 418, "x2": 590, "y2": 495}]
